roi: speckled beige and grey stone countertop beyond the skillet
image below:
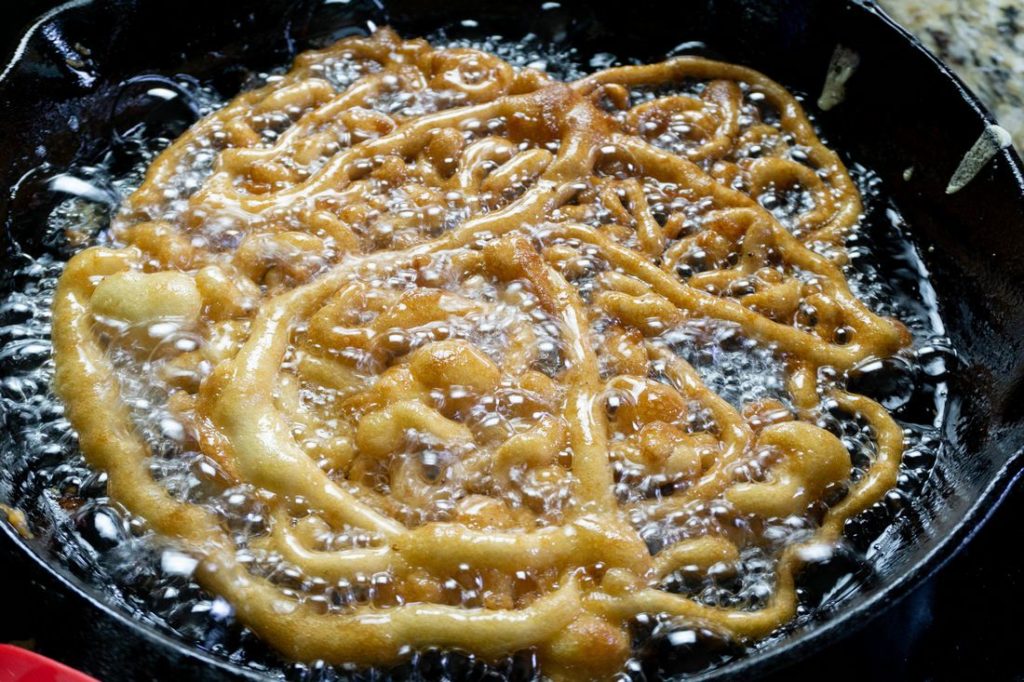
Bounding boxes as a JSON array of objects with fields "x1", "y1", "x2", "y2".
[{"x1": 879, "y1": 0, "x2": 1024, "y2": 151}]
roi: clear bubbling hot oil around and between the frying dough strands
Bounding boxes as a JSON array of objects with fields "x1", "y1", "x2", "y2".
[{"x1": 0, "y1": 23, "x2": 955, "y2": 680}]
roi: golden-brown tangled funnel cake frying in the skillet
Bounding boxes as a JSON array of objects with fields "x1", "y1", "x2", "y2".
[{"x1": 53, "y1": 30, "x2": 909, "y2": 678}]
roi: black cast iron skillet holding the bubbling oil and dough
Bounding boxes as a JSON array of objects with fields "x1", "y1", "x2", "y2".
[{"x1": 0, "y1": 0, "x2": 1024, "y2": 680}]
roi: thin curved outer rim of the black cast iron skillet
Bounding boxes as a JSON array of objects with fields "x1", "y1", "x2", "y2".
[{"x1": 0, "y1": 0, "x2": 1024, "y2": 682}]
